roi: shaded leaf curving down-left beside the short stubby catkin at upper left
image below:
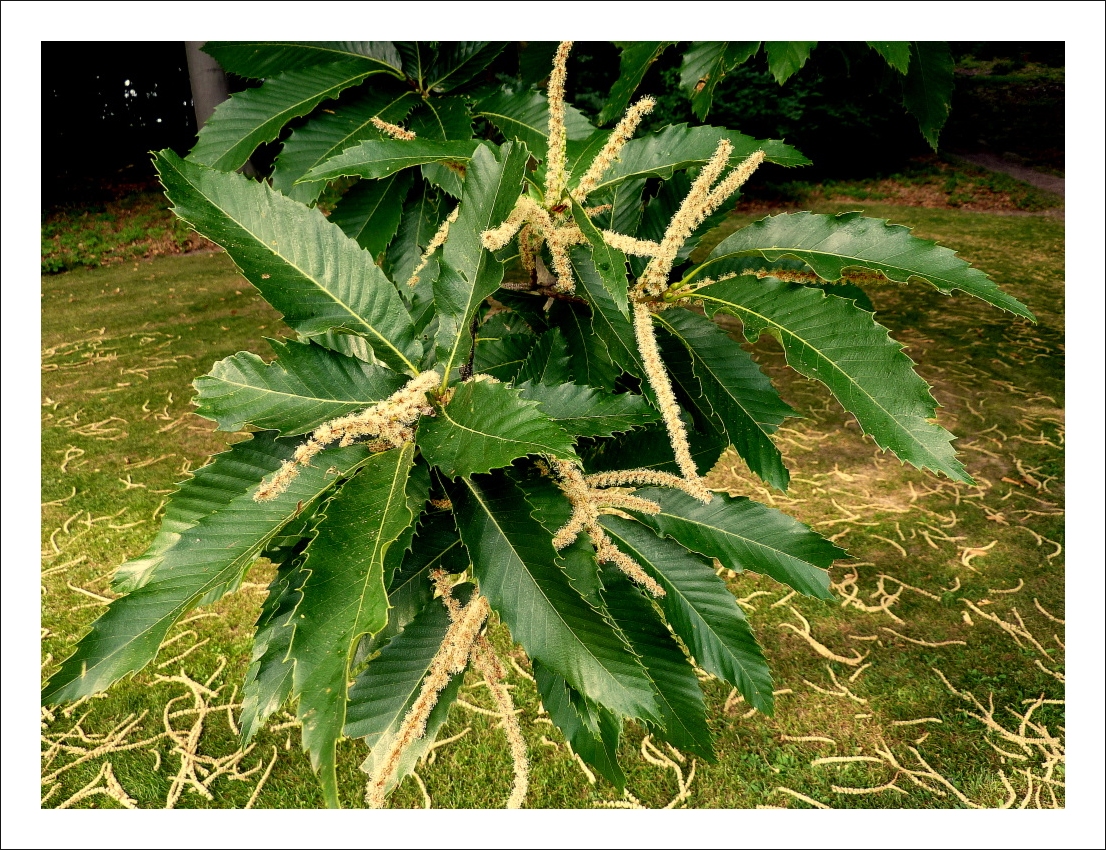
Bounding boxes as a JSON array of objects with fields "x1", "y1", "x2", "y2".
[{"x1": 272, "y1": 81, "x2": 418, "y2": 203}]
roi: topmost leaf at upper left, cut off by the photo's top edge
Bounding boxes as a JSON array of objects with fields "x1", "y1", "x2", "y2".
[{"x1": 204, "y1": 41, "x2": 403, "y2": 80}]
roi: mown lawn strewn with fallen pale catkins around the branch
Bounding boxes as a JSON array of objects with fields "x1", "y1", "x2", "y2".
[{"x1": 42, "y1": 203, "x2": 1064, "y2": 808}]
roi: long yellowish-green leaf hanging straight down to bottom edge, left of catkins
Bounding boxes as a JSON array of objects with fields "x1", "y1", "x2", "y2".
[{"x1": 289, "y1": 443, "x2": 425, "y2": 808}]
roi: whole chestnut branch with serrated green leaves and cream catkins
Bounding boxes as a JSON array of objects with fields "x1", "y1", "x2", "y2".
[{"x1": 43, "y1": 42, "x2": 1031, "y2": 806}]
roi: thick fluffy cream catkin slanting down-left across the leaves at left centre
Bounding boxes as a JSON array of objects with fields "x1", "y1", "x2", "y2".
[{"x1": 253, "y1": 369, "x2": 441, "y2": 502}]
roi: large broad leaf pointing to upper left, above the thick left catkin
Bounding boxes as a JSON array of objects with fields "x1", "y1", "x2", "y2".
[{"x1": 155, "y1": 150, "x2": 421, "y2": 374}]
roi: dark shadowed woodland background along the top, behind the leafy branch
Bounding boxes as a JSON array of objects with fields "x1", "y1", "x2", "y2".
[{"x1": 42, "y1": 42, "x2": 1064, "y2": 209}]
